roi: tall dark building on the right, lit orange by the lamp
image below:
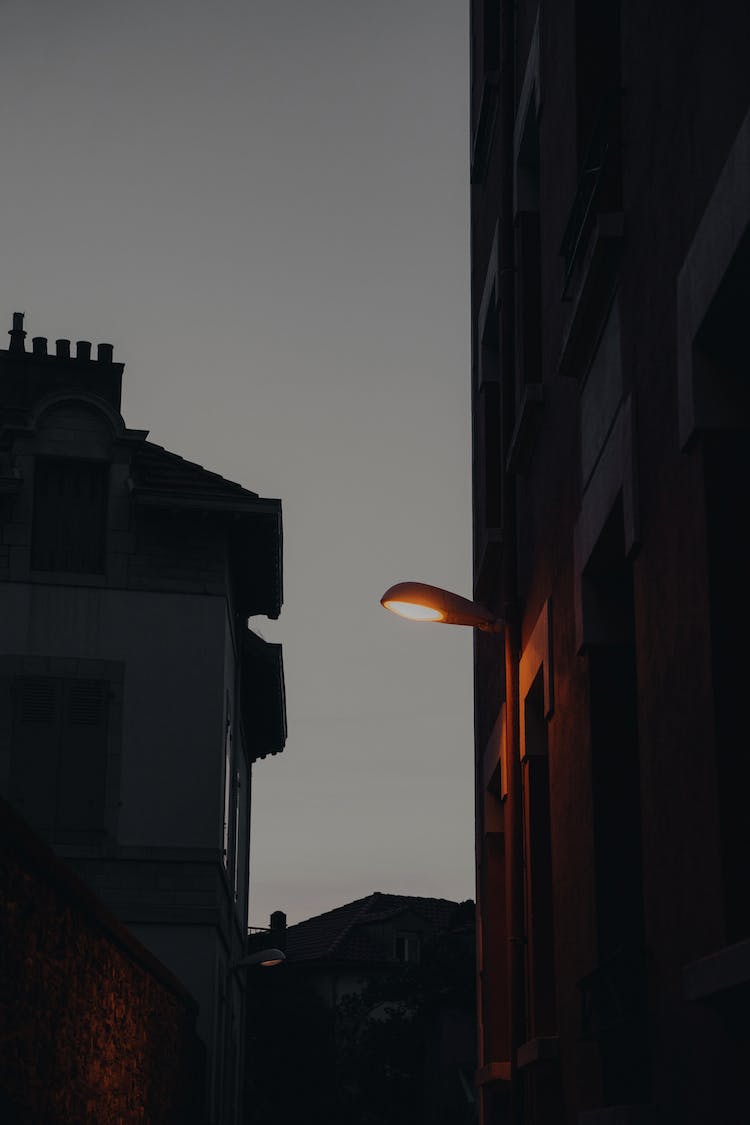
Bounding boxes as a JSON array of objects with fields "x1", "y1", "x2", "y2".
[{"x1": 471, "y1": 0, "x2": 750, "y2": 1125}]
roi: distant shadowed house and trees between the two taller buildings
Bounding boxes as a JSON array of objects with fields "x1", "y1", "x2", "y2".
[{"x1": 247, "y1": 892, "x2": 476, "y2": 1125}]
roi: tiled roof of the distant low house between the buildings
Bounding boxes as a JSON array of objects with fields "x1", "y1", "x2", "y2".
[{"x1": 287, "y1": 891, "x2": 459, "y2": 962}]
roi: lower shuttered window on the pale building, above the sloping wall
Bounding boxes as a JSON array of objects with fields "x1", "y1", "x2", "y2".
[{"x1": 10, "y1": 676, "x2": 109, "y2": 844}]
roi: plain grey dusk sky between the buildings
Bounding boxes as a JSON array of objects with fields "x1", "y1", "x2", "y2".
[{"x1": 0, "y1": 0, "x2": 475, "y2": 926}]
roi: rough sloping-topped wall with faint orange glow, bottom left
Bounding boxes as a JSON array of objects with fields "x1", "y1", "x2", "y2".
[{"x1": 0, "y1": 802, "x2": 202, "y2": 1125}]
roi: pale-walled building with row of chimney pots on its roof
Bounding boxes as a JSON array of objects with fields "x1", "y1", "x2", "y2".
[{"x1": 0, "y1": 314, "x2": 286, "y2": 1125}]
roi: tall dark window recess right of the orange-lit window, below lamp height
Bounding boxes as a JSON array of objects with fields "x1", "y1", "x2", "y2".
[{"x1": 581, "y1": 510, "x2": 650, "y2": 1105}]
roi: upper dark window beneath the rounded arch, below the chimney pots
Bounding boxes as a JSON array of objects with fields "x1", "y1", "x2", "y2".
[{"x1": 31, "y1": 458, "x2": 109, "y2": 574}]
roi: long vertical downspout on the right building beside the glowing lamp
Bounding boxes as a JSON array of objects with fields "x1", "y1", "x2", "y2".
[{"x1": 499, "y1": 0, "x2": 526, "y2": 1125}]
